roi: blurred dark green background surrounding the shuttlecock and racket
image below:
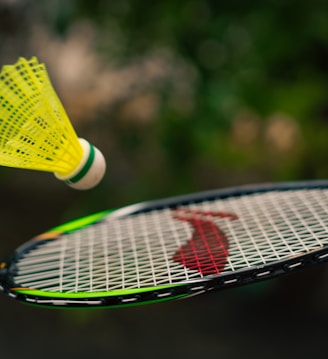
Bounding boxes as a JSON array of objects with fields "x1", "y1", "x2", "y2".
[{"x1": 0, "y1": 0, "x2": 328, "y2": 359}]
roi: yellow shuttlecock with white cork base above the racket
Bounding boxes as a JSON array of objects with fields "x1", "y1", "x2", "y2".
[{"x1": 0, "y1": 57, "x2": 106, "y2": 189}]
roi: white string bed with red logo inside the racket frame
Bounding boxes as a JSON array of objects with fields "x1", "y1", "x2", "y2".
[{"x1": 7, "y1": 189, "x2": 328, "y2": 301}]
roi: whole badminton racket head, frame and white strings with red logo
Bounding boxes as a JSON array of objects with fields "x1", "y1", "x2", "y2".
[{"x1": 0, "y1": 181, "x2": 328, "y2": 308}]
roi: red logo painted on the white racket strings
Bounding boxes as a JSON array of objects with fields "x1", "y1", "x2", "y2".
[{"x1": 172, "y1": 208, "x2": 238, "y2": 275}]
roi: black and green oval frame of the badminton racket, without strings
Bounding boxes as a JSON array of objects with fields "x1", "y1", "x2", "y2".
[{"x1": 0, "y1": 180, "x2": 328, "y2": 308}]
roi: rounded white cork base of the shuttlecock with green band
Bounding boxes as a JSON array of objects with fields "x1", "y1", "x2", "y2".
[{"x1": 55, "y1": 138, "x2": 106, "y2": 190}]
